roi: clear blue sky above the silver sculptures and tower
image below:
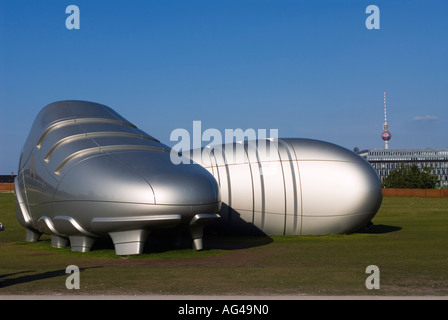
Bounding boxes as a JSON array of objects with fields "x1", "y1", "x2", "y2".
[{"x1": 0, "y1": 0, "x2": 448, "y2": 174}]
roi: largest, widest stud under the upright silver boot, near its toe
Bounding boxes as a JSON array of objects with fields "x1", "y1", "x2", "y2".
[{"x1": 109, "y1": 229, "x2": 149, "y2": 255}]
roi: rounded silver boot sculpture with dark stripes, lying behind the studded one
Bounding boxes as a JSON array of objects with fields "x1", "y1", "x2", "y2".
[{"x1": 184, "y1": 138, "x2": 383, "y2": 235}]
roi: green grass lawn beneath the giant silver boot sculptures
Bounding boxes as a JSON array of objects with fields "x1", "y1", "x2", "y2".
[{"x1": 0, "y1": 194, "x2": 448, "y2": 296}]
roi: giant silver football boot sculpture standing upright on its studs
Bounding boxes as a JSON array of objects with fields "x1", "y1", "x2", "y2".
[{"x1": 14, "y1": 101, "x2": 221, "y2": 255}]
